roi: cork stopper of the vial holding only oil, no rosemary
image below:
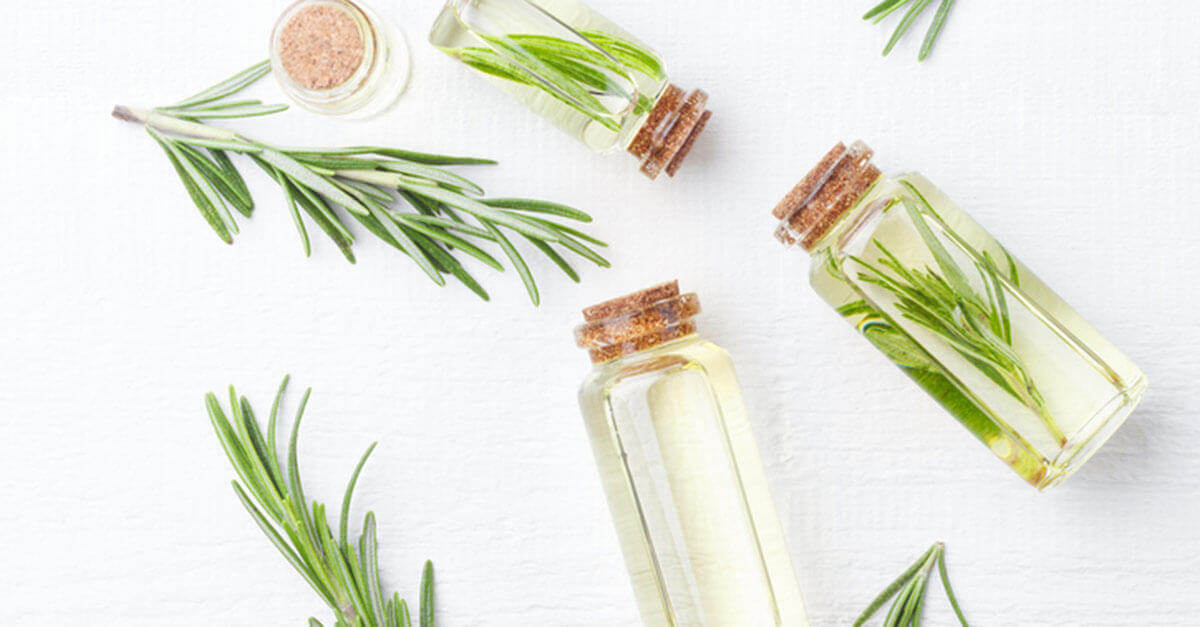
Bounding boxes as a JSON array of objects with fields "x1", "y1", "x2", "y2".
[{"x1": 575, "y1": 281, "x2": 700, "y2": 364}]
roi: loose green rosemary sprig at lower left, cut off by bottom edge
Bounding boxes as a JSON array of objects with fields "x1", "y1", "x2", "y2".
[{"x1": 204, "y1": 377, "x2": 433, "y2": 627}]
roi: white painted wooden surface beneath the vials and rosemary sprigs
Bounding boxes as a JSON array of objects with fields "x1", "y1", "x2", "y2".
[{"x1": 0, "y1": 0, "x2": 1200, "y2": 627}]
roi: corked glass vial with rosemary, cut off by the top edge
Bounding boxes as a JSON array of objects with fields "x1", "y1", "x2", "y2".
[{"x1": 430, "y1": 0, "x2": 712, "y2": 179}]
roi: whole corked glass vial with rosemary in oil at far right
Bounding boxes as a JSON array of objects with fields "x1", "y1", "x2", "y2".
[{"x1": 774, "y1": 142, "x2": 1146, "y2": 490}]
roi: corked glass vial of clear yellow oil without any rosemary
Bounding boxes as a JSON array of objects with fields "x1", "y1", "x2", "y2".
[{"x1": 575, "y1": 281, "x2": 808, "y2": 627}]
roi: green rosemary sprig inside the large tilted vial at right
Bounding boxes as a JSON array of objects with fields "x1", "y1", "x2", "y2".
[{"x1": 851, "y1": 194, "x2": 1067, "y2": 444}]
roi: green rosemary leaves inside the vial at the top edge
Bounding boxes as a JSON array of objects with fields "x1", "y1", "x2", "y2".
[{"x1": 446, "y1": 30, "x2": 666, "y2": 132}]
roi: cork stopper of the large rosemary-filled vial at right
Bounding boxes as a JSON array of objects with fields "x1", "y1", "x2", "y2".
[{"x1": 772, "y1": 142, "x2": 881, "y2": 250}]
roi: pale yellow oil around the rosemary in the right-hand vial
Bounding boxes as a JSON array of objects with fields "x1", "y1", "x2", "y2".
[{"x1": 810, "y1": 173, "x2": 1146, "y2": 489}]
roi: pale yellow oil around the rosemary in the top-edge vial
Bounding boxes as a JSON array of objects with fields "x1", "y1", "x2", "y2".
[{"x1": 430, "y1": 0, "x2": 667, "y2": 153}]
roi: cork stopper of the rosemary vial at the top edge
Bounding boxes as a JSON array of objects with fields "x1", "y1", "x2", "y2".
[{"x1": 626, "y1": 84, "x2": 713, "y2": 179}]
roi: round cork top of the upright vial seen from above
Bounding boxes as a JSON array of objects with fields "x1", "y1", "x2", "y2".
[{"x1": 280, "y1": 4, "x2": 366, "y2": 90}]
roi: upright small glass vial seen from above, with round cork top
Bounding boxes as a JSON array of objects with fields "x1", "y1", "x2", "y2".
[{"x1": 271, "y1": 0, "x2": 408, "y2": 118}]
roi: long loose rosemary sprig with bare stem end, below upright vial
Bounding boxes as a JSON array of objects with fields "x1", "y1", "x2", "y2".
[{"x1": 113, "y1": 61, "x2": 610, "y2": 305}]
